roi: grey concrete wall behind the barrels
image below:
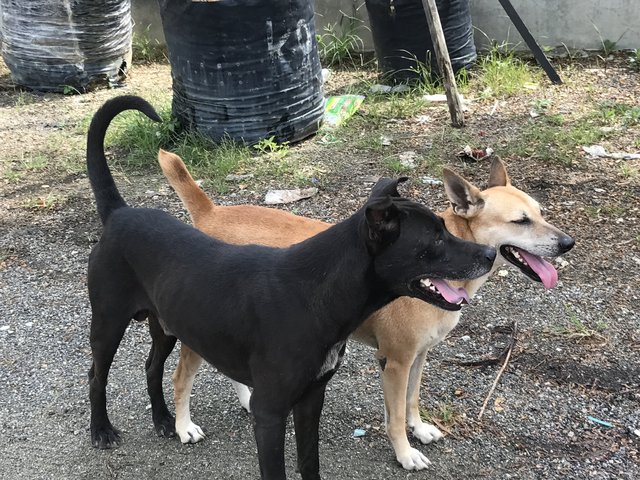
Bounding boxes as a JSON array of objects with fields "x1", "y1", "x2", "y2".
[{"x1": 132, "y1": 0, "x2": 640, "y2": 50}]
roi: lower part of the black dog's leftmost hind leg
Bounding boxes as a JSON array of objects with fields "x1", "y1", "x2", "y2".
[{"x1": 89, "y1": 314, "x2": 130, "y2": 449}]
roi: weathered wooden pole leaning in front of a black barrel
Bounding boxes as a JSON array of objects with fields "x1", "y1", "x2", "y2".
[{"x1": 422, "y1": 0, "x2": 464, "y2": 128}]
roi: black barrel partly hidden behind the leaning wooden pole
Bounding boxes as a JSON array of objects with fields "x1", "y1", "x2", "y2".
[{"x1": 365, "y1": 0, "x2": 477, "y2": 81}]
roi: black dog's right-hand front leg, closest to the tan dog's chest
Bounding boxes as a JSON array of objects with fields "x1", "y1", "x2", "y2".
[{"x1": 293, "y1": 382, "x2": 327, "y2": 480}]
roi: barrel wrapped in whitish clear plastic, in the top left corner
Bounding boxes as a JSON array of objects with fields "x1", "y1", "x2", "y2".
[{"x1": 0, "y1": 0, "x2": 132, "y2": 92}]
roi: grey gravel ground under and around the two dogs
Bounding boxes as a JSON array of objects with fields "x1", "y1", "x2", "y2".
[{"x1": 0, "y1": 61, "x2": 640, "y2": 480}]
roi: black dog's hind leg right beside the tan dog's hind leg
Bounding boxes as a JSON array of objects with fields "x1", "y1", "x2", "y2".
[{"x1": 145, "y1": 314, "x2": 176, "y2": 437}]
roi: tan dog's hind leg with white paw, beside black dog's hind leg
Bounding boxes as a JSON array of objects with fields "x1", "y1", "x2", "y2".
[{"x1": 172, "y1": 343, "x2": 205, "y2": 443}]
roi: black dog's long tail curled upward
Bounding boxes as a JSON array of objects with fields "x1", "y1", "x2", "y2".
[{"x1": 87, "y1": 95, "x2": 162, "y2": 224}]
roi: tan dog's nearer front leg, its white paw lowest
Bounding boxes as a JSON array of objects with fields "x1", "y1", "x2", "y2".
[{"x1": 379, "y1": 350, "x2": 431, "y2": 470}]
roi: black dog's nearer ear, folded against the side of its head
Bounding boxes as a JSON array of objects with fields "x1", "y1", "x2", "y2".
[{"x1": 365, "y1": 195, "x2": 401, "y2": 255}]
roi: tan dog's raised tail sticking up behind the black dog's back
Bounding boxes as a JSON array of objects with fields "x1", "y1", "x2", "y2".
[{"x1": 158, "y1": 149, "x2": 215, "y2": 223}]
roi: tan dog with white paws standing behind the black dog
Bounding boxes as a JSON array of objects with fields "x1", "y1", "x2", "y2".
[{"x1": 158, "y1": 150, "x2": 574, "y2": 470}]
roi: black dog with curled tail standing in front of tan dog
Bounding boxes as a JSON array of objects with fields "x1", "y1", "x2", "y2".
[{"x1": 87, "y1": 97, "x2": 496, "y2": 479}]
